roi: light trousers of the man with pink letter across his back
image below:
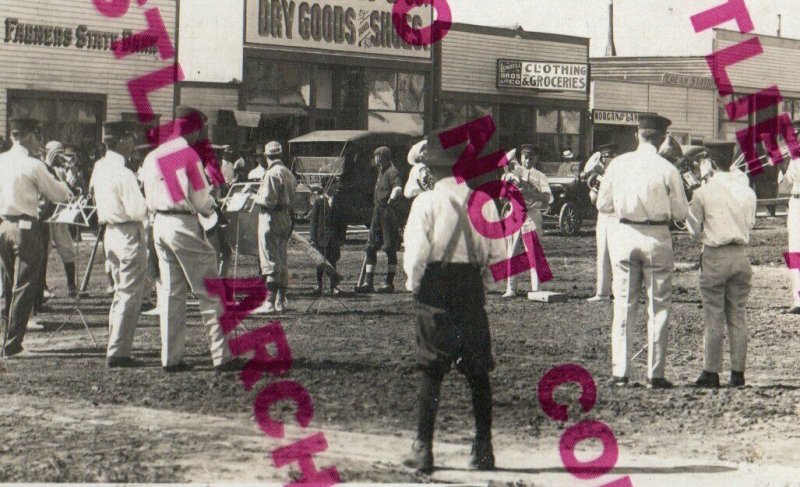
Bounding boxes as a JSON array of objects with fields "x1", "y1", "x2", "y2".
[{"x1": 153, "y1": 213, "x2": 231, "y2": 367}]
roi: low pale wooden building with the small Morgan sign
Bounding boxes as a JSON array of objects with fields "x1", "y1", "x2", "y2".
[{"x1": 591, "y1": 56, "x2": 717, "y2": 152}]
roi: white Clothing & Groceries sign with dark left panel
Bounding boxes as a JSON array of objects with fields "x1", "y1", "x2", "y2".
[{"x1": 497, "y1": 59, "x2": 588, "y2": 92}]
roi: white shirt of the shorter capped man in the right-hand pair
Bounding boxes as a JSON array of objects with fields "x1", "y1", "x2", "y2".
[{"x1": 686, "y1": 171, "x2": 756, "y2": 247}]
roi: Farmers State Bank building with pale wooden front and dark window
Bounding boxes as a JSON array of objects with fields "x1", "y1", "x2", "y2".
[{"x1": 0, "y1": 0, "x2": 176, "y2": 157}]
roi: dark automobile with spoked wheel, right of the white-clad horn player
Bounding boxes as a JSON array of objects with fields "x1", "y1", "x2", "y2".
[{"x1": 539, "y1": 161, "x2": 597, "y2": 237}]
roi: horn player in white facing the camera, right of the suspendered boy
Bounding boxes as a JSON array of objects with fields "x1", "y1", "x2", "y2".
[{"x1": 503, "y1": 144, "x2": 553, "y2": 298}]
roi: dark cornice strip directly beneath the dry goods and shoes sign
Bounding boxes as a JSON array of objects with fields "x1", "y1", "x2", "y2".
[{"x1": 244, "y1": 44, "x2": 433, "y2": 71}]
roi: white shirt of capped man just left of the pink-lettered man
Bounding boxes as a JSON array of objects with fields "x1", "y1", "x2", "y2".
[{"x1": 89, "y1": 149, "x2": 147, "y2": 223}]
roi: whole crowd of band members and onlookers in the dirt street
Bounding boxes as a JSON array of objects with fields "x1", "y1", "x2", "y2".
[{"x1": 0, "y1": 107, "x2": 800, "y2": 471}]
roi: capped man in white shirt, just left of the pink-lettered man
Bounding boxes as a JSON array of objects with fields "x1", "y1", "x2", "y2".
[{"x1": 89, "y1": 122, "x2": 147, "y2": 367}]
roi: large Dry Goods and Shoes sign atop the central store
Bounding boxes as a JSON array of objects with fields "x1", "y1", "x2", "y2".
[{"x1": 245, "y1": 0, "x2": 432, "y2": 59}]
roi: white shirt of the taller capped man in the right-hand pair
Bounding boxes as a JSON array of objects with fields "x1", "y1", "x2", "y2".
[{"x1": 597, "y1": 143, "x2": 689, "y2": 222}]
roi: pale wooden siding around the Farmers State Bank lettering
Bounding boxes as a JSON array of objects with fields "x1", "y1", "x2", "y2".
[{"x1": 0, "y1": 0, "x2": 176, "y2": 135}]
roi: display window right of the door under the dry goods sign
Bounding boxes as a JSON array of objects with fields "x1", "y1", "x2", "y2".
[{"x1": 367, "y1": 71, "x2": 425, "y2": 134}]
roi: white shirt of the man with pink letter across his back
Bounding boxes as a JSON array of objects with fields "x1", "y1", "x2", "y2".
[{"x1": 139, "y1": 137, "x2": 214, "y2": 215}]
